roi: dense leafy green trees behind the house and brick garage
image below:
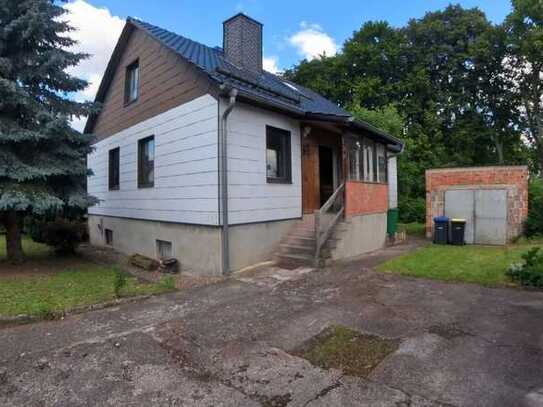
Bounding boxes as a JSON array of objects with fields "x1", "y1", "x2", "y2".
[{"x1": 286, "y1": 0, "x2": 543, "y2": 225}]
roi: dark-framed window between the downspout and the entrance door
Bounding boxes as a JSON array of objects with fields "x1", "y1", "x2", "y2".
[{"x1": 266, "y1": 126, "x2": 292, "y2": 183}]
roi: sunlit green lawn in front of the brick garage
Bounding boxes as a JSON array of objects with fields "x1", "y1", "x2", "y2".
[{"x1": 377, "y1": 242, "x2": 543, "y2": 286}]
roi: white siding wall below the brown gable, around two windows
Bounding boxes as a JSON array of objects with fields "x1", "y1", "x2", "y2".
[{"x1": 88, "y1": 95, "x2": 219, "y2": 225}]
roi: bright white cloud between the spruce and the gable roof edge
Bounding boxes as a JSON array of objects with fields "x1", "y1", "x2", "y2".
[{"x1": 63, "y1": 0, "x2": 125, "y2": 130}]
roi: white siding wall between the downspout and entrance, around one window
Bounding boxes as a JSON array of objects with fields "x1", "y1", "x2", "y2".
[{"x1": 224, "y1": 103, "x2": 302, "y2": 224}]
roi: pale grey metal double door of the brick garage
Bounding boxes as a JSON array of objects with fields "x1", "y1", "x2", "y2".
[{"x1": 445, "y1": 189, "x2": 507, "y2": 244}]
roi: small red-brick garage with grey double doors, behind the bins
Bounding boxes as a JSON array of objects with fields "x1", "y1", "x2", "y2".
[{"x1": 426, "y1": 166, "x2": 528, "y2": 245}]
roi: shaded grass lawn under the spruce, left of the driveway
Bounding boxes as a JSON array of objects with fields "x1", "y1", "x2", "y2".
[{"x1": 0, "y1": 238, "x2": 175, "y2": 317}]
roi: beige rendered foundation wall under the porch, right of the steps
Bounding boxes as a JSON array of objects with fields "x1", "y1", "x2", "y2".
[{"x1": 330, "y1": 212, "x2": 387, "y2": 260}]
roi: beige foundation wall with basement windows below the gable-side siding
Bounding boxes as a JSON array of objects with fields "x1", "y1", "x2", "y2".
[{"x1": 89, "y1": 215, "x2": 222, "y2": 276}]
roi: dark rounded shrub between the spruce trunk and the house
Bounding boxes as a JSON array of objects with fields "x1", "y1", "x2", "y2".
[{"x1": 27, "y1": 219, "x2": 87, "y2": 254}]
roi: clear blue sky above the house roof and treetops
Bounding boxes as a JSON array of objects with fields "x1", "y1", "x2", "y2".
[{"x1": 84, "y1": 0, "x2": 511, "y2": 68}]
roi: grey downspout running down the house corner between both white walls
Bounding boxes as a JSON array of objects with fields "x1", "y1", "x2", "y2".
[{"x1": 219, "y1": 88, "x2": 238, "y2": 275}]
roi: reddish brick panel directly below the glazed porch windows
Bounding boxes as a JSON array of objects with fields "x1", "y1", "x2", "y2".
[{"x1": 345, "y1": 181, "x2": 388, "y2": 216}]
